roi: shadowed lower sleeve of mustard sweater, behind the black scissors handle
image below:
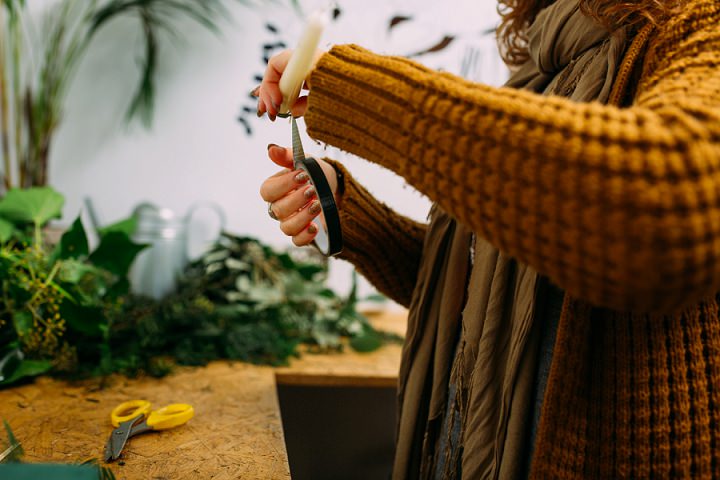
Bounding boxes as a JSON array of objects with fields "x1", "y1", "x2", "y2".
[{"x1": 324, "y1": 158, "x2": 426, "y2": 307}]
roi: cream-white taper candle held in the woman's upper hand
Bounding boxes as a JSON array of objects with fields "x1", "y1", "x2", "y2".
[{"x1": 278, "y1": 12, "x2": 328, "y2": 114}]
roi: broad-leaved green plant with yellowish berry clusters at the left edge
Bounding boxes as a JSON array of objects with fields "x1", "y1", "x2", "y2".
[{"x1": 0, "y1": 188, "x2": 144, "y2": 386}]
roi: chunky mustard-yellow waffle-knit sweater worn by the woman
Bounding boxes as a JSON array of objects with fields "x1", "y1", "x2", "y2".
[{"x1": 306, "y1": 0, "x2": 720, "y2": 479}]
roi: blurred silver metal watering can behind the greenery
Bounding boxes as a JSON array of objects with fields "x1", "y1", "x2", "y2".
[{"x1": 129, "y1": 203, "x2": 225, "y2": 299}]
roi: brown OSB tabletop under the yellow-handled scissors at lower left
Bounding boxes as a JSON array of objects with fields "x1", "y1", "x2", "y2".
[{"x1": 0, "y1": 362, "x2": 290, "y2": 480}]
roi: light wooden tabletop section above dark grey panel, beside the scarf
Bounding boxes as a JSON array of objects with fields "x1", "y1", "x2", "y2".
[{"x1": 276, "y1": 311, "x2": 407, "y2": 387}]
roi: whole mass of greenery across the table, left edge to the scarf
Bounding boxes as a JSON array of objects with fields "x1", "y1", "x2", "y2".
[{"x1": 0, "y1": 187, "x2": 401, "y2": 388}]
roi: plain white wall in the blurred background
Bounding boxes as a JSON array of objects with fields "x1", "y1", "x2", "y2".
[{"x1": 39, "y1": 0, "x2": 506, "y2": 300}]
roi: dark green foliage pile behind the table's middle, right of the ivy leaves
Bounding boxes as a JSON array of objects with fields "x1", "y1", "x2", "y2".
[{"x1": 111, "y1": 233, "x2": 401, "y2": 375}]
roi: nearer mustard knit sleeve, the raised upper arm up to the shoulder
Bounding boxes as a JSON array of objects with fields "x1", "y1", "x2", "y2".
[{"x1": 306, "y1": 4, "x2": 720, "y2": 311}]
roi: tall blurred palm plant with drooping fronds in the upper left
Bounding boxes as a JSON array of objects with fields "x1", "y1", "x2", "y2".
[{"x1": 0, "y1": 0, "x2": 272, "y2": 191}]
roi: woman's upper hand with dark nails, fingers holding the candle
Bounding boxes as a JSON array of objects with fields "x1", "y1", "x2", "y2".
[{"x1": 253, "y1": 50, "x2": 325, "y2": 121}]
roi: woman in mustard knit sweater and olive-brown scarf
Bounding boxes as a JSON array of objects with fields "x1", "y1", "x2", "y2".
[{"x1": 258, "y1": 0, "x2": 720, "y2": 479}]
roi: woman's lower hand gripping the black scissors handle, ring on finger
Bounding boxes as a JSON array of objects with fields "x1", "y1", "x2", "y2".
[{"x1": 260, "y1": 144, "x2": 337, "y2": 246}]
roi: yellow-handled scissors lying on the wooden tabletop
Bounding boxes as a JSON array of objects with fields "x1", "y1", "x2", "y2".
[{"x1": 105, "y1": 400, "x2": 195, "y2": 462}]
